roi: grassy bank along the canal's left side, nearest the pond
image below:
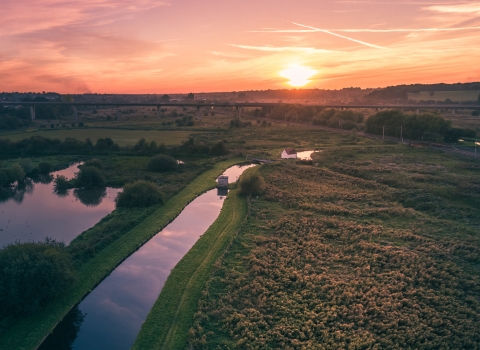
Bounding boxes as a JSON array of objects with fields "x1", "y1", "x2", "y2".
[{"x1": 0, "y1": 159, "x2": 240, "y2": 350}]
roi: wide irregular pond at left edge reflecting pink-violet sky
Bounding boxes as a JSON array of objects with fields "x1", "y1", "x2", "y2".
[{"x1": 0, "y1": 164, "x2": 120, "y2": 247}]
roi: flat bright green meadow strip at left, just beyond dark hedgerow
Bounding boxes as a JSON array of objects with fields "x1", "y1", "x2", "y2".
[{"x1": 0, "y1": 128, "x2": 199, "y2": 146}]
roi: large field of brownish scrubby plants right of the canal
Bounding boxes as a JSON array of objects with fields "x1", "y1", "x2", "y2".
[{"x1": 189, "y1": 147, "x2": 480, "y2": 349}]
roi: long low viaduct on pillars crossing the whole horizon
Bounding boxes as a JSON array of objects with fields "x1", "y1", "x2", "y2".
[{"x1": 0, "y1": 101, "x2": 480, "y2": 122}]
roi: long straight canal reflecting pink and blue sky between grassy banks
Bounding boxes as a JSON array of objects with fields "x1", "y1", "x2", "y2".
[{"x1": 39, "y1": 165, "x2": 252, "y2": 350}]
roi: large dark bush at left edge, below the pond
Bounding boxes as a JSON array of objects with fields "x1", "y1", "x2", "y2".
[{"x1": 0, "y1": 239, "x2": 74, "y2": 319}]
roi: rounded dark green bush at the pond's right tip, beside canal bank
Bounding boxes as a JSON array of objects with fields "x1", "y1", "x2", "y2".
[{"x1": 115, "y1": 180, "x2": 163, "y2": 208}]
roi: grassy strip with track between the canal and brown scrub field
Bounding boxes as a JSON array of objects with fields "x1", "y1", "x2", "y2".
[{"x1": 133, "y1": 180, "x2": 248, "y2": 350}]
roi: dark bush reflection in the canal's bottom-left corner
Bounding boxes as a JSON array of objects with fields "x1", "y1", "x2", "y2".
[{"x1": 38, "y1": 306, "x2": 86, "y2": 350}]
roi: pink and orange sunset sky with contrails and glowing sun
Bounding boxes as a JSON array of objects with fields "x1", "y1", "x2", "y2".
[{"x1": 0, "y1": 0, "x2": 480, "y2": 94}]
